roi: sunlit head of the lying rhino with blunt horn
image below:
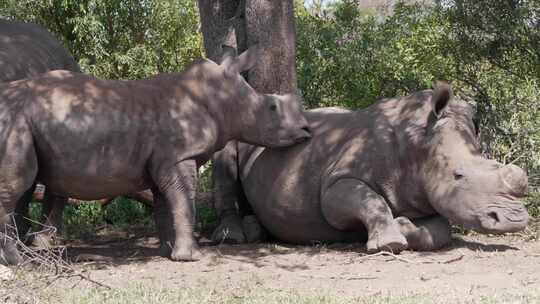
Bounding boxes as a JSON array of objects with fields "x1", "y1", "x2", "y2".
[{"x1": 422, "y1": 83, "x2": 529, "y2": 233}]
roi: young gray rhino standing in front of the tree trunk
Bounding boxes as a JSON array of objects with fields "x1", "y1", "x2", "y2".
[{"x1": 0, "y1": 50, "x2": 310, "y2": 264}]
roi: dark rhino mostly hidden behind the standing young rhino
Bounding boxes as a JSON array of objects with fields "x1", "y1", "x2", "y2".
[{"x1": 0, "y1": 20, "x2": 80, "y2": 247}]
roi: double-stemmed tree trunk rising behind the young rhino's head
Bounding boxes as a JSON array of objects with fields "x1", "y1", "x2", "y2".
[{"x1": 199, "y1": 0, "x2": 297, "y2": 94}]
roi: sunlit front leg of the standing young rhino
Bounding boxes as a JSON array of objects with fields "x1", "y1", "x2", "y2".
[{"x1": 152, "y1": 160, "x2": 201, "y2": 261}]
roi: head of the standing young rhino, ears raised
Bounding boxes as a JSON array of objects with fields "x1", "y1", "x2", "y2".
[{"x1": 213, "y1": 46, "x2": 311, "y2": 148}]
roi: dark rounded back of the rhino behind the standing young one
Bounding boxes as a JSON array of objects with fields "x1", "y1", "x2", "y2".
[{"x1": 0, "y1": 20, "x2": 80, "y2": 82}]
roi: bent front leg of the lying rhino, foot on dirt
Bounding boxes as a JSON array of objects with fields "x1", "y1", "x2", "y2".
[{"x1": 321, "y1": 178, "x2": 407, "y2": 253}]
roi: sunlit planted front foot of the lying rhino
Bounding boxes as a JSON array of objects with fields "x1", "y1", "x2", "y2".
[{"x1": 366, "y1": 224, "x2": 408, "y2": 253}]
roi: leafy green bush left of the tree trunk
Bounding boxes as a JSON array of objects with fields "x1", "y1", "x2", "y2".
[{"x1": 0, "y1": 0, "x2": 202, "y2": 79}]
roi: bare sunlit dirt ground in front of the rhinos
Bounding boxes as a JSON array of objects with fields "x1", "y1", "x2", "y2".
[{"x1": 53, "y1": 224, "x2": 540, "y2": 303}]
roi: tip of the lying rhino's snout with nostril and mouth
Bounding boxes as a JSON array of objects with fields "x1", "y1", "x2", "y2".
[{"x1": 480, "y1": 203, "x2": 529, "y2": 234}]
